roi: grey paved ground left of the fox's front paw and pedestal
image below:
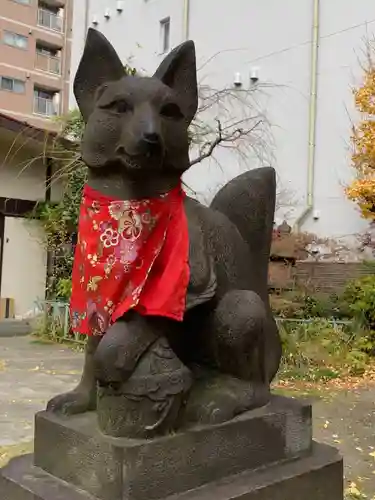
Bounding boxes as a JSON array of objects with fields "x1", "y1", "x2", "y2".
[{"x1": 0, "y1": 337, "x2": 82, "y2": 446}]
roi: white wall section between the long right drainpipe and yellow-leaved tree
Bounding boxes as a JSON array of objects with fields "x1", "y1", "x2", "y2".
[{"x1": 307, "y1": 0, "x2": 375, "y2": 236}]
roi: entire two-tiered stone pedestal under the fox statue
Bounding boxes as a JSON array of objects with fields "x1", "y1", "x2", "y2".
[{"x1": 0, "y1": 397, "x2": 343, "y2": 500}]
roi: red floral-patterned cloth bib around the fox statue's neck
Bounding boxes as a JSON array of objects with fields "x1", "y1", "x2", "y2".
[{"x1": 70, "y1": 185, "x2": 189, "y2": 335}]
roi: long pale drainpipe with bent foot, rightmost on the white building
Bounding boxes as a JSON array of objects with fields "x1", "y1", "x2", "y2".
[{"x1": 294, "y1": 0, "x2": 320, "y2": 232}]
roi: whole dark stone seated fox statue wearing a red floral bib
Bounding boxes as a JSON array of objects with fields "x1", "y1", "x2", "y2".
[{"x1": 47, "y1": 29, "x2": 281, "y2": 432}]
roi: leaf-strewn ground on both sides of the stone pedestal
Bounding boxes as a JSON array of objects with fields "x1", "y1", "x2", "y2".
[{"x1": 0, "y1": 337, "x2": 375, "y2": 499}]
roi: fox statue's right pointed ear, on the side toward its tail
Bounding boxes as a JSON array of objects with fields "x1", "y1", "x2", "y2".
[{"x1": 154, "y1": 40, "x2": 198, "y2": 123}]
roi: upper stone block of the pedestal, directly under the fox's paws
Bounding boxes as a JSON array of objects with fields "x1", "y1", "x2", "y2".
[{"x1": 34, "y1": 397, "x2": 312, "y2": 500}]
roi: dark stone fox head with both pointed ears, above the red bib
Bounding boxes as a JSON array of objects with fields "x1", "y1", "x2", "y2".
[{"x1": 74, "y1": 28, "x2": 198, "y2": 188}]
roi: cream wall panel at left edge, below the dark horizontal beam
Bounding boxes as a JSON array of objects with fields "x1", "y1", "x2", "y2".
[{"x1": 1, "y1": 217, "x2": 47, "y2": 316}]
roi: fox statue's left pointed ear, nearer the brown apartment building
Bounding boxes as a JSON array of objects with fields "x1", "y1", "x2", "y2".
[{"x1": 73, "y1": 28, "x2": 125, "y2": 122}]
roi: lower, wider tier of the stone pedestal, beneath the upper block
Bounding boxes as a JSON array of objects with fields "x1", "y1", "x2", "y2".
[{"x1": 0, "y1": 444, "x2": 343, "y2": 500}]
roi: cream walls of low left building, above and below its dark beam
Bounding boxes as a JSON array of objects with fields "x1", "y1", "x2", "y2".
[{"x1": 0, "y1": 130, "x2": 62, "y2": 315}]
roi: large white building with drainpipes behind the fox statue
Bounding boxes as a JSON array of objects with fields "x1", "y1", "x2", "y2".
[{"x1": 70, "y1": 0, "x2": 375, "y2": 239}]
